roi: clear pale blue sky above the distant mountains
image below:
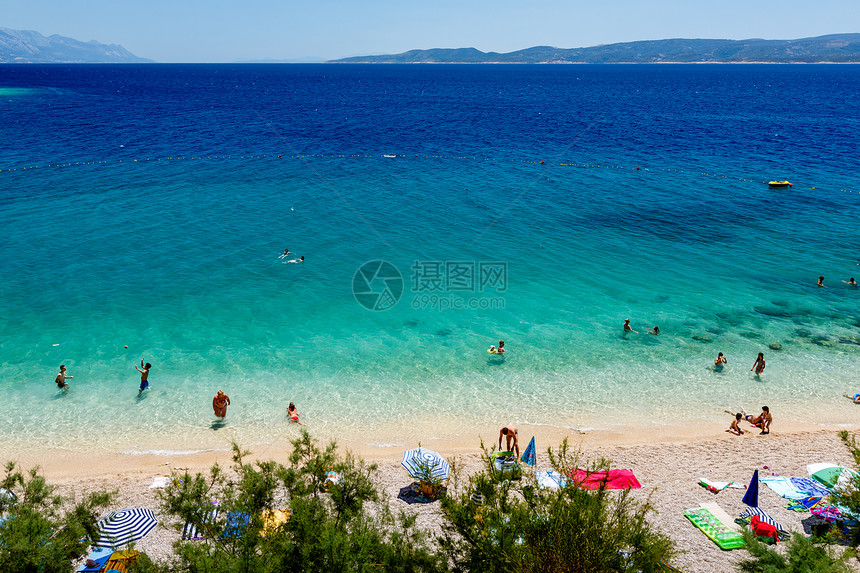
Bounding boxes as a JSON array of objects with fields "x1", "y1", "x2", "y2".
[{"x1": 6, "y1": 0, "x2": 860, "y2": 62}]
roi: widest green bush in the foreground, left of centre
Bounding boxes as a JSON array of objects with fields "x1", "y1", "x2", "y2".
[{"x1": 138, "y1": 431, "x2": 444, "y2": 573}]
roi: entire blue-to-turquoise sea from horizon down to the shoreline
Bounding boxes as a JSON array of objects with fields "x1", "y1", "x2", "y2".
[{"x1": 0, "y1": 65, "x2": 860, "y2": 452}]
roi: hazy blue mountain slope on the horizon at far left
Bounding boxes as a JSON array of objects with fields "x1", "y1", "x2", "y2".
[{"x1": 0, "y1": 28, "x2": 152, "y2": 64}]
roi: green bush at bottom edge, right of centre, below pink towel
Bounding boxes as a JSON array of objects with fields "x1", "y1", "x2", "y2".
[{"x1": 441, "y1": 440, "x2": 675, "y2": 573}]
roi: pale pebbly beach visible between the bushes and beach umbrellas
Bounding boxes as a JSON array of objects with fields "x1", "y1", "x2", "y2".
[{"x1": 10, "y1": 424, "x2": 856, "y2": 573}]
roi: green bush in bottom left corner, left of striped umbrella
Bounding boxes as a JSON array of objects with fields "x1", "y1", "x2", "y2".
[{"x1": 0, "y1": 462, "x2": 113, "y2": 573}]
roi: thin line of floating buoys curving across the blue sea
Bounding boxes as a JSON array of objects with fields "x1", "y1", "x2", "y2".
[{"x1": 0, "y1": 153, "x2": 860, "y2": 195}]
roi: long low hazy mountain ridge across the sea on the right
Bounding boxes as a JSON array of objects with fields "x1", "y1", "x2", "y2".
[{"x1": 331, "y1": 34, "x2": 860, "y2": 64}]
